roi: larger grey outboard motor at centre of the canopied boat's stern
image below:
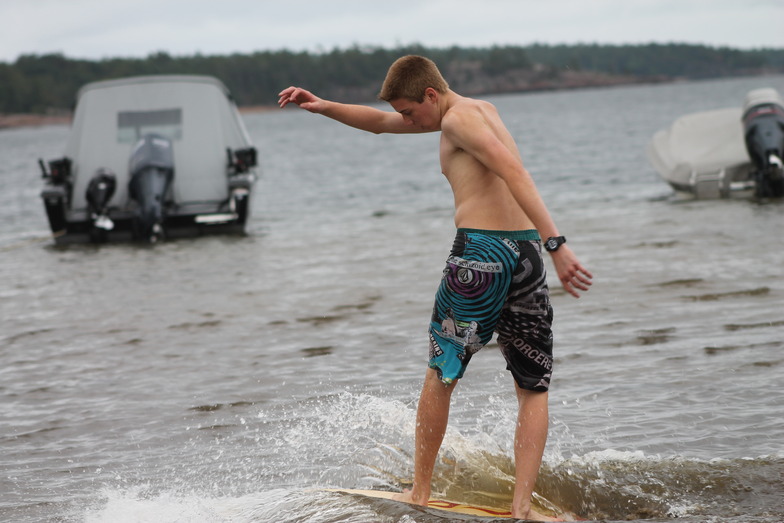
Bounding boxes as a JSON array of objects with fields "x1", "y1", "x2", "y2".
[{"x1": 128, "y1": 134, "x2": 174, "y2": 243}]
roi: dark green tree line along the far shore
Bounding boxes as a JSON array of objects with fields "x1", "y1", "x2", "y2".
[{"x1": 0, "y1": 44, "x2": 784, "y2": 114}]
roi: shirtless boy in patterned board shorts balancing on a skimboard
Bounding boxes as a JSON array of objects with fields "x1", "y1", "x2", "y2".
[{"x1": 279, "y1": 56, "x2": 592, "y2": 521}]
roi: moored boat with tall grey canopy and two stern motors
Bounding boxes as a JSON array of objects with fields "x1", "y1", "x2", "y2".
[{"x1": 39, "y1": 75, "x2": 257, "y2": 243}]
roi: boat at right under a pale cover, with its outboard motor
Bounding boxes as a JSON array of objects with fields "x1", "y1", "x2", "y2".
[{"x1": 647, "y1": 88, "x2": 784, "y2": 198}]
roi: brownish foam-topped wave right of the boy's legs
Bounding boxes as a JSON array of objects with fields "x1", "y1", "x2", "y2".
[{"x1": 541, "y1": 451, "x2": 784, "y2": 521}]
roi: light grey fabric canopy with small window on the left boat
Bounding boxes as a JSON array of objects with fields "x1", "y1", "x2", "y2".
[{"x1": 65, "y1": 75, "x2": 251, "y2": 210}]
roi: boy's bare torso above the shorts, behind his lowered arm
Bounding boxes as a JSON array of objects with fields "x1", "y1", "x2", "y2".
[{"x1": 439, "y1": 98, "x2": 534, "y2": 230}]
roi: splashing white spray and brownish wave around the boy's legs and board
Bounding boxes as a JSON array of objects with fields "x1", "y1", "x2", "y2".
[{"x1": 75, "y1": 393, "x2": 784, "y2": 523}]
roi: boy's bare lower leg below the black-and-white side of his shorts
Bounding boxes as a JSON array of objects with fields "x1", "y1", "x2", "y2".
[{"x1": 512, "y1": 383, "x2": 563, "y2": 521}]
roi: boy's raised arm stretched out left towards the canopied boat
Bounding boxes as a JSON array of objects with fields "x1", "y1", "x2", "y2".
[{"x1": 278, "y1": 86, "x2": 421, "y2": 134}]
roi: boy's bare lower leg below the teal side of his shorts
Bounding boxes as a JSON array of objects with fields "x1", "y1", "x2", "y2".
[{"x1": 396, "y1": 369, "x2": 457, "y2": 505}]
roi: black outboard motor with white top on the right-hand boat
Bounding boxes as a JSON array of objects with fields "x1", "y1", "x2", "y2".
[{"x1": 743, "y1": 88, "x2": 784, "y2": 198}]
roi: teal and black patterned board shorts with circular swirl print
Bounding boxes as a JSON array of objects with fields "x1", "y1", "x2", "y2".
[{"x1": 429, "y1": 229, "x2": 553, "y2": 391}]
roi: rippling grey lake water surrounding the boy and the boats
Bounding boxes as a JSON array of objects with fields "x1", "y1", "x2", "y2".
[{"x1": 0, "y1": 76, "x2": 784, "y2": 523}]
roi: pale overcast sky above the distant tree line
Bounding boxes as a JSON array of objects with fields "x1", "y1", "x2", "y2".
[{"x1": 0, "y1": 0, "x2": 784, "y2": 62}]
